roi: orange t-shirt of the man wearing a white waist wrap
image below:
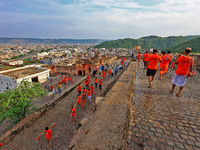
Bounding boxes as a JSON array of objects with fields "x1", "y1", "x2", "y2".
[{"x1": 175, "y1": 56, "x2": 194, "y2": 75}]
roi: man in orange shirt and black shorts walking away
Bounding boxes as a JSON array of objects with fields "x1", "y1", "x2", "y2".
[{"x1": 146, "y1": 49, "x2": 162, "y2": 88}]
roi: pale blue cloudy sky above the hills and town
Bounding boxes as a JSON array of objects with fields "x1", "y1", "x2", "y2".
[{"x1": 0, "y1": 0, "x2": 200, "y2": 39}]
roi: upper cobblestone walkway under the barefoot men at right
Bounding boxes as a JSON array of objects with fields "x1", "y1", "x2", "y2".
[{"x1": 127, "y1": 66, "x2": 200, "y2": 150}]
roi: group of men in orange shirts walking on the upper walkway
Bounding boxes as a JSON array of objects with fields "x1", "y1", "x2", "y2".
[{"x1": 135, "y1": 47, "x2": 195, "y2": 97}]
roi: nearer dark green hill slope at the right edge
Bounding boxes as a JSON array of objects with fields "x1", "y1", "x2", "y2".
[{"x1": 170, "y1": 37, "x2": 200, "y2": 53}]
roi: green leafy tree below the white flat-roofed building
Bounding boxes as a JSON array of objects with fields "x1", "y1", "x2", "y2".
[{"x1": 0, "y1": 81, "x2": 46, "y2": 124}]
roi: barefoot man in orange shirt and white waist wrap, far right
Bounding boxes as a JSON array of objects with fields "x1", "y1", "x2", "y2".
[{"x1": 170, "y1": 47, "x2": 194, "y2": 97}]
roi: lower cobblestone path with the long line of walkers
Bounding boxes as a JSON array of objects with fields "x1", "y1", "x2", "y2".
[{"x1": 1, "y1": 60, "x2": 126, "y2": 150}]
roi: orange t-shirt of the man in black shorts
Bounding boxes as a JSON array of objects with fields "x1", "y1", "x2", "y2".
[{"x1": 147, "y1": 54, "x2": 162, "y2": 70}]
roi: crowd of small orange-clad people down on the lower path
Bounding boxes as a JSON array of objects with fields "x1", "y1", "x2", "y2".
[{"x1": 36, "y1": 58, "x2": 127, "y2": 147}]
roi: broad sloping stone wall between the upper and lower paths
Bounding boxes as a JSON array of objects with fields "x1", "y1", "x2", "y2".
[{"x1": 73, "y1": 62, "x2": 135, "y2": 150}]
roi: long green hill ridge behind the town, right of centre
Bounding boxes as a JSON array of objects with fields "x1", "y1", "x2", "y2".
[{"x1": 96, "y1": 36, "x2": 197, "y2": 49}]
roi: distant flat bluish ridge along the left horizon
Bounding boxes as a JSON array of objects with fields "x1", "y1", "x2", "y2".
[{"x1": 0, "y1": 38, "x2": 106, "y2": 44}]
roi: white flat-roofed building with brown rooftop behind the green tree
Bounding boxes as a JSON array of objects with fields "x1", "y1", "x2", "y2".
[{"x1": 0, "y1": 65, "x2": 50, "y2": 93}]
